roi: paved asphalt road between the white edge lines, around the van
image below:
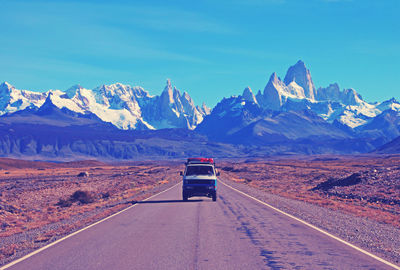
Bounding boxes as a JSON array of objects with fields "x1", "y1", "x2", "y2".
[{"x1": 3, "y1": 180, "x2": 393, "y2": 270}]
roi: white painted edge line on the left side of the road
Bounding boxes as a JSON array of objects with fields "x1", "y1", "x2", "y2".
[{"x1": 0, "y1": 182, "x2": 181, "y2": 270}]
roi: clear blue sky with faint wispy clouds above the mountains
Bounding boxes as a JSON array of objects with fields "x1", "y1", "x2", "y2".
[{"x1": 0, "y1": 0, "x2": 400, "y2": 106}]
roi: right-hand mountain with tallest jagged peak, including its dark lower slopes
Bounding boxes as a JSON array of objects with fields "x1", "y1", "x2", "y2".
[{"x1": 196, "y1": 61, "x2": 400, "y2": 152}]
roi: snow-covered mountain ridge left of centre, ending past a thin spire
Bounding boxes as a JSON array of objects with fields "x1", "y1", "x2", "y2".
[{"x1": 0, "y1": 80, "x2": 211, "y2": 130}]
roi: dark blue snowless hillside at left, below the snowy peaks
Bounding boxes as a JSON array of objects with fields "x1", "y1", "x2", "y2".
[{"x1": 0, "y1": 100, "x2": 243, "y2": 160}]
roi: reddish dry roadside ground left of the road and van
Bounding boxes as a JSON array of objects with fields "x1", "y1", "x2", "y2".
[{"x1": 0, "y1": 159, "x2": 183, "y2": 265}]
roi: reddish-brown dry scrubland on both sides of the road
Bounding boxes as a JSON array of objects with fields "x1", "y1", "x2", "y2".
[{"x1": 0, "y1": 156, "x2": 400, "y2": 265}]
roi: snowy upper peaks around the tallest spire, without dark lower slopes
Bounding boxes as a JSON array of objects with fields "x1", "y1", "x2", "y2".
[{"x1": 216, "y1": 61, "x2": 400, "y2": 131}]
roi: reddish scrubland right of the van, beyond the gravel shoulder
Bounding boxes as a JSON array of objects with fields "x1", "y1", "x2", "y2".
[{"x1": 219, "y1": 156, "x2": 400, "y2": 228}]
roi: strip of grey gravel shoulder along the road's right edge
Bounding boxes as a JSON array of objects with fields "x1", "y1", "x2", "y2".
[{"x1": 221, "y1": 175, "x2": 400, "y2": 265}]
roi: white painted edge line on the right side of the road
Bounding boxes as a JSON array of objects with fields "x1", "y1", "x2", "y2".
[{"x1": 218, "y1": 179, "x2": 400, "y2": 270}]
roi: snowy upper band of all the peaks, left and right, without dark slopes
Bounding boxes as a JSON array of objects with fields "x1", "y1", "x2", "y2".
[{"x1": 0, "y1": 60, "x2": 400, "y2": 134}]
